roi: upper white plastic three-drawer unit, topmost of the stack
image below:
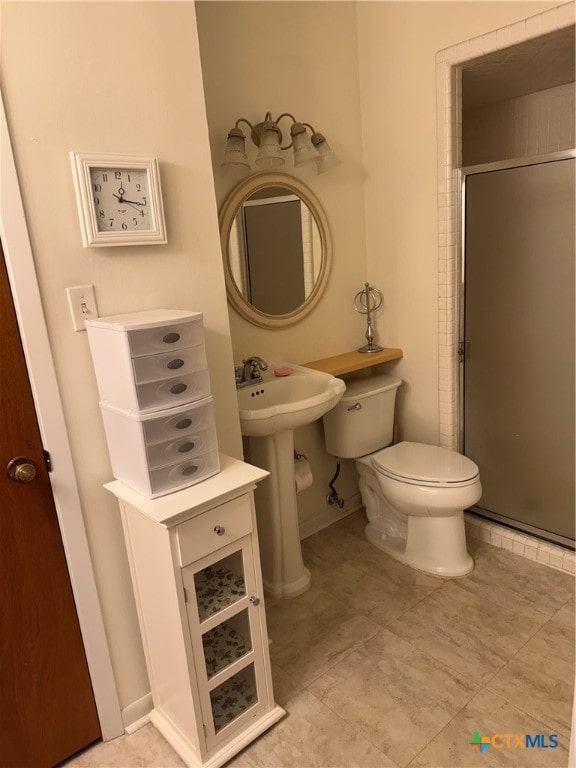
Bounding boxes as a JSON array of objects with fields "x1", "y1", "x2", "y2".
[{"x1": 86, "y1": 310, "x2": 210, "y2": 413}]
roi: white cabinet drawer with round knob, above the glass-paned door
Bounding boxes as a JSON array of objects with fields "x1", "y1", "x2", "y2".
[{"x1": 178, "y1": 496, "x2": 252, "y2": 567}]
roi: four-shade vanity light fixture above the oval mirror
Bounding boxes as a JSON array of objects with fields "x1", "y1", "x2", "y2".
[{"x1": 221, "y1": 112, "x2": 341, "y2": 173}]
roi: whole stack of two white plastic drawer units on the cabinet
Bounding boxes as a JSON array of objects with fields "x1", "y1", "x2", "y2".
[{"x1": 86, "y1": 310, "x2": 220, "y2": 499}]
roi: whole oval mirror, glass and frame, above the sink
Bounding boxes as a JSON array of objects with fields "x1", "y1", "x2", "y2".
[{"x1": 220, "y1": 173, "x2": 332, "y2": 328}]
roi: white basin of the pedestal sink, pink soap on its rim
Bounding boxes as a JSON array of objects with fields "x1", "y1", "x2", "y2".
[{"x1": 237, "y1": 363, "x2": 346, "y2": 437}]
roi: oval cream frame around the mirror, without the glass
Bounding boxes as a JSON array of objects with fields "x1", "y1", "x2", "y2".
[{"x1": 219, "y1": 172, "x2": 332, "y2": 329}]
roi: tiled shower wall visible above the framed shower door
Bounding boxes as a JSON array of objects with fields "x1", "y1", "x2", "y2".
[{"x1": 462, "y1": 83, "x2": 574, "y2": 166}]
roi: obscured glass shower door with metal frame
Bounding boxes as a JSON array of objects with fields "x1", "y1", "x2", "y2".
[{"x1": 460, "y1": 153, "x2": 575, "y2": 547}]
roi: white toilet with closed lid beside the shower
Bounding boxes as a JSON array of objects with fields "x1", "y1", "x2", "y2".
[{"x1": 324, "y1": 375, "x2": 482, "y2": 576}]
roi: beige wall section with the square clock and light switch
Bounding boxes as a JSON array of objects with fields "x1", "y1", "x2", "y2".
[{"x1": 1, "y1": 2, "x2": 241, "y2": 707}]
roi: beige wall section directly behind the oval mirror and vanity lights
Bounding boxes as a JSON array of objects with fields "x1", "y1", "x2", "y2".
[{"x1": 196, "y1": 0, "x2": 366, "y2": 533}]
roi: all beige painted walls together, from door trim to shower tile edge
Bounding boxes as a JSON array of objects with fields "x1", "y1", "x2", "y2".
[{"x1": 0, "y1": 2, "x2": 568, "y2": 720}]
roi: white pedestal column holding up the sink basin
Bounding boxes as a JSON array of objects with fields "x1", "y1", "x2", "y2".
[{"x1": 249, "y1": 429, "x2": 310, "y2": 598}]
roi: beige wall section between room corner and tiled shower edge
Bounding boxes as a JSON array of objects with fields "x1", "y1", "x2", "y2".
[{"x1": 358, "y1": 2, "x2": 557, "y2": 443}]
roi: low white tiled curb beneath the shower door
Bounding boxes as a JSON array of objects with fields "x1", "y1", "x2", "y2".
[{"x1": 464, "y1": 512, "x2": 576, "y2": 576}]
